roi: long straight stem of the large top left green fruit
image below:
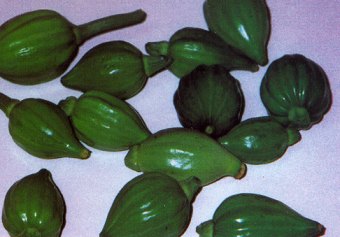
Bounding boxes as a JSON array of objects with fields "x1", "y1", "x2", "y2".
[{"x1": 74, "y1": 9, "x2": 146, "y2": 45}]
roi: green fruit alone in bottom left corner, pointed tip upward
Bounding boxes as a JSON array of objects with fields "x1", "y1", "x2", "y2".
[{"x1": 2, "y1": 169, "x2": 65, "y2": 237}]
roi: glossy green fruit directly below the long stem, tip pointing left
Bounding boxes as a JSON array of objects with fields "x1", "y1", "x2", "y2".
[{"x1": 61, "y1": 41, "x2": 171, "y2": 99}]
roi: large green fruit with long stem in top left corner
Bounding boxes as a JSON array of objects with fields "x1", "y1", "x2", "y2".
[{"x1": 0, "y1": 10, "x2": 146, "y2": 85}]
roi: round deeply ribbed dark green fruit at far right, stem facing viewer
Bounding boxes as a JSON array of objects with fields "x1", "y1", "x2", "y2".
[{"x1": 260, "y1": 54, "x2": 332, "y2": 129}]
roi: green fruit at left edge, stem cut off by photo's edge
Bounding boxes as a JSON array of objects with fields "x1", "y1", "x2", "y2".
[{"x1": 0, "y1": 93, "x2": 91, "y2": 159}]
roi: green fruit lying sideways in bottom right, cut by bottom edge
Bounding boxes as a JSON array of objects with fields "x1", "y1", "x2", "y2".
[{"x1": 196, "y1": 193, "x2": 325, "y2": 237}]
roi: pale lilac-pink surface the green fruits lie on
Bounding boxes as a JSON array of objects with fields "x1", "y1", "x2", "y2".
[{"x1": 0, "y1": 0, "x2": 340, "y2": 237}]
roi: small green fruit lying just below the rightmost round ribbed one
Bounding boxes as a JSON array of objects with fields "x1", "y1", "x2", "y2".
[{"x1": 218, "y1": 117, "x2": 301, "y2": 165}]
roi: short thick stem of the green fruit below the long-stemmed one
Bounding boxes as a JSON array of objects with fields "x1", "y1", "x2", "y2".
[{"x1": 143, "y1": 55, "x2": 172, "y2": 77}]
